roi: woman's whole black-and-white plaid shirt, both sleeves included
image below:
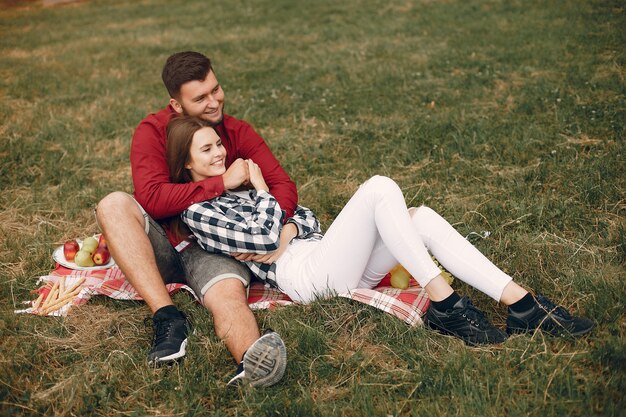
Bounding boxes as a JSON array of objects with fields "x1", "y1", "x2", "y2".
[{"x1": 181, "y1": 190, "x2": 321, "y2": 287}]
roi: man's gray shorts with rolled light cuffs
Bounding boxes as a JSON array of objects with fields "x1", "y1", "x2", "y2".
[{"x1": 129, "y1": 195, "x2": 250, "y2": 302}]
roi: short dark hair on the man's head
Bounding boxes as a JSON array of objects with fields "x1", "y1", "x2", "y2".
[{"x1": 161, "y1": 51, "x2": 213, "y2": 98}]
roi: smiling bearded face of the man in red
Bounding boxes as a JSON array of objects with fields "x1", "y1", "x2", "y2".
[{"x1": 170, "y1": 71, "x2": 224, "y2": 124}]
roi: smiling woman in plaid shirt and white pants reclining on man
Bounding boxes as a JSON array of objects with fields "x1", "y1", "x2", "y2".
[{"x1": 167, "y1": 116, "x2": 594, "y2": 345}]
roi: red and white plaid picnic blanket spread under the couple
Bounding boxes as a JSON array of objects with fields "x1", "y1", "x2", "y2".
[{"x1": 15, "y1": 264, "x2": 430, "y2": 326}]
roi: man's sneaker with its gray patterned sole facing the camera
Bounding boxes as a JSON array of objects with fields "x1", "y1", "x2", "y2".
[{"x1": 228, "y1": 330, "x2": 287, "y2": 387}]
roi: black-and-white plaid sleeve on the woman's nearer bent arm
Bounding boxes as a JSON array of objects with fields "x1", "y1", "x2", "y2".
[{"x1": 181, "y1": 191, "x2": 283, "y2": 253}]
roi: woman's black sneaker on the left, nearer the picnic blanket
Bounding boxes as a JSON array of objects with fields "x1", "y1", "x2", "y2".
[{"x1": 426, "y1": 297, "x2": 507, "y2": 346}]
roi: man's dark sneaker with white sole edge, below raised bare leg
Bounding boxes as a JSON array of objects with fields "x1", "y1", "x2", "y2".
[{"x1": 144, "y1": 312, "x2": 191, "y2": 364}]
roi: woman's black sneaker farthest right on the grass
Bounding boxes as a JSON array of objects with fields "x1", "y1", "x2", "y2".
[{"x1": 506, "y1": 294, "x2": 595, "y2": 336}]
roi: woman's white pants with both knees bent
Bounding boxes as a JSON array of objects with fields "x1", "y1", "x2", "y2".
[{"x1": 276, "y1": 176, "x2": 511, "y2": 303}]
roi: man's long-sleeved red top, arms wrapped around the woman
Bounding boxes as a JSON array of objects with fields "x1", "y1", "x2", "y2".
[{"x1": 130, "y1": 106, "x2": 298, "y2": 246}]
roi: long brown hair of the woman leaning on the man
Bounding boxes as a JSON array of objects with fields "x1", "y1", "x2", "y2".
[{"x1": 166, "y1": 116, "x2": 211, "y2": 239}]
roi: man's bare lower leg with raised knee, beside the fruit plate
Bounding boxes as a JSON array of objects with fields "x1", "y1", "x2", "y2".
[{"x1": 96, "y1": 192, "x2": 173, "y2": 313}]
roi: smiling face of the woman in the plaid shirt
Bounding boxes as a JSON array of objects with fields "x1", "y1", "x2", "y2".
[{"x1": 185, "y1": 127, "x2": 226, "y2": 182}]
